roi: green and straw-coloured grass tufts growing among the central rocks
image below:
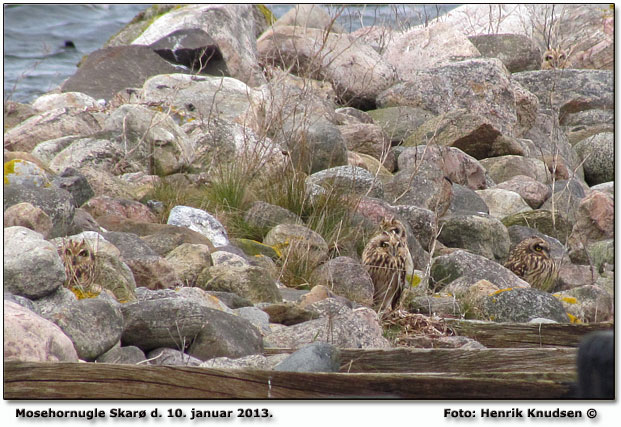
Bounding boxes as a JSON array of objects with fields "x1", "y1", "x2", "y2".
[{"x1": 147, "y1": 162, "x2": 367, "y2": 286}]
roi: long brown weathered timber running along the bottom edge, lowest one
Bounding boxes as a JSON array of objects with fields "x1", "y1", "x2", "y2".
[{"x1": 4, "y1": 362, "x2": 572, "y2": 400}]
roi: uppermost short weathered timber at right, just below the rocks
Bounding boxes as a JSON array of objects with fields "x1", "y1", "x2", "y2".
[{"x1": 445, "y1": 319, "x2": 614, "y2": 348}]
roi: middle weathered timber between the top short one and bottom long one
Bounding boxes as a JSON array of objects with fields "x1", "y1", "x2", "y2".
[{"x1": 265, "y1": 347, "x2": 578, "y2": 374}]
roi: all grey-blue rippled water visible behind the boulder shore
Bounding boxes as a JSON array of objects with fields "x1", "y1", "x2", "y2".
[{"x1": 4, "y1": 4, "x2": 456, "y2": 102}]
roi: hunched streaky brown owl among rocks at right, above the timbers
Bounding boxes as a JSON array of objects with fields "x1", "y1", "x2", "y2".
[{"x1": 505, "y1": 237, "x2": 558, "y2": 291}]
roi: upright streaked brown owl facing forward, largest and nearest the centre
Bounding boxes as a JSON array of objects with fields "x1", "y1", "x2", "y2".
[{"x1": 362, "y1": 231, "x2": 409, "y2": 312}]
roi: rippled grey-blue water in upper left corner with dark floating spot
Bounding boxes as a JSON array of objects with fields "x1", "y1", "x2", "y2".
[{"x1": 4, "y1": 4, "x2": 148, "y2": 102}]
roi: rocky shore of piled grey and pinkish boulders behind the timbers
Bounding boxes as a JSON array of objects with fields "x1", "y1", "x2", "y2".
[{"x1": 3, "y1": 5, "x2": 614, "y2": 371}]
